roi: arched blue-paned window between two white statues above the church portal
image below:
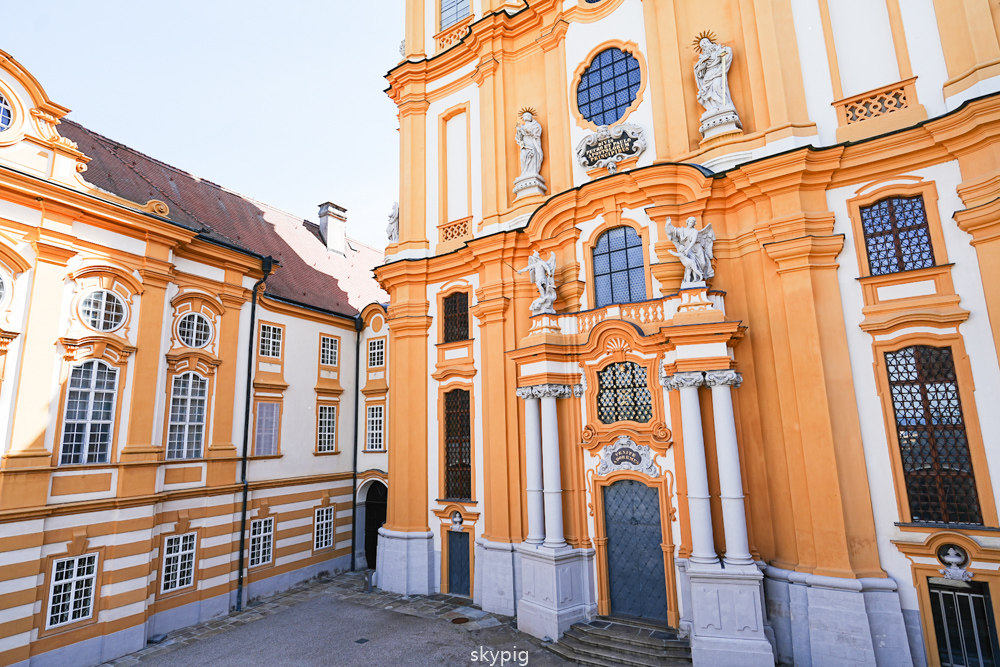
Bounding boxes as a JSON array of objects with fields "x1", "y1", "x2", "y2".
[{"x1": 594, "y1": 226, "x2": 646, "y2": 308}]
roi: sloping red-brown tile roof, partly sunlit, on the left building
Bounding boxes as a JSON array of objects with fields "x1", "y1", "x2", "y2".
[{"x1": 59, "y1": 119, "x2": 389, "y2": 315}]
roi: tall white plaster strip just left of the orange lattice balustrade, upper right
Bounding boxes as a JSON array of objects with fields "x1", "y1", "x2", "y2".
[{"x1": 791, "y1": 0, "x2": 840, "y2": 145}]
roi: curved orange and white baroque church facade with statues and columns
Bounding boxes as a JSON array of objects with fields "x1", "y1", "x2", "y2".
[{"x1": 376, "y1": 0, "x2": 1000, "y2": 667}]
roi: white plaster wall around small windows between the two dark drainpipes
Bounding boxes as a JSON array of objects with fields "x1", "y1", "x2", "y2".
[{"x1": 247, "y1": 304, "x2": 355, "y2": 481}]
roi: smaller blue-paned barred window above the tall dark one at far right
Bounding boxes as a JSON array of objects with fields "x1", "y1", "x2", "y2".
[{"x1": 861, "y1": 195, "x2": 934, "y2": 276}]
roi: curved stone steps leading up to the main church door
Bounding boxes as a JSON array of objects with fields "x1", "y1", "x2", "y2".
[{"x1": 548, "y1": 618, "x2": 691, "y2": 667}]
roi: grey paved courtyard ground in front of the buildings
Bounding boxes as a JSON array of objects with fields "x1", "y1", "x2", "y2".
[{"x1": 102, "y1": 572, "x2": 575, "y2": 667}]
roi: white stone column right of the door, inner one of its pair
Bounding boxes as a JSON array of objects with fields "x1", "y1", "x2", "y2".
[{"x1": 663, "y1": 372, "x2": 719, "y2": 565}]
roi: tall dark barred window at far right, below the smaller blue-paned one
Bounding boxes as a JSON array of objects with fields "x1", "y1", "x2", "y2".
[{"x1": 885, "y1": 345, "x2": 983, "y2": 524}]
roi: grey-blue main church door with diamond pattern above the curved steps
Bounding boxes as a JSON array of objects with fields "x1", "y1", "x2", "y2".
[{"x1": 604, "y1": 479, "x2": 667, "y2": 624}]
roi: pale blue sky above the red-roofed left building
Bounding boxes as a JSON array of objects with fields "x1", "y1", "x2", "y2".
[{"x1": 0, "y1": 0, "x2": 404, "y2": 248}]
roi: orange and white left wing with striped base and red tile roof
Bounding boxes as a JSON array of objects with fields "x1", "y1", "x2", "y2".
[{"x1": 0, "y1": 52, "x2": 391, "y2": 667}]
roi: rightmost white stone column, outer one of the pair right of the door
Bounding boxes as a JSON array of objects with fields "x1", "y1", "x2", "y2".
[{"x1": 705, "y1": 370, "x2": 753, "y2": 565}]
